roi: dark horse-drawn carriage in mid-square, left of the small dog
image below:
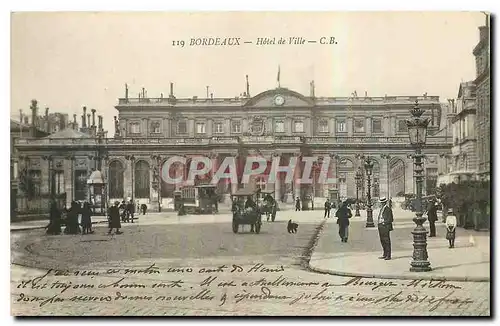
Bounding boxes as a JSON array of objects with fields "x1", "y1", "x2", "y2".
[{"x1": 231, "y1": 189, "x2": 262, "y2": 234}]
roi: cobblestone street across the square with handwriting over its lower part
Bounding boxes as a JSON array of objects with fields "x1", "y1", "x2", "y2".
[{"x1": 11, "y1": 212, "x2": 490, "y2": 316}]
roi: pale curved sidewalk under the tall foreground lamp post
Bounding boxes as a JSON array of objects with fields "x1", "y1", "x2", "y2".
[{"x1": 309, "y1": 211, "x2": 490, "y2": 282}]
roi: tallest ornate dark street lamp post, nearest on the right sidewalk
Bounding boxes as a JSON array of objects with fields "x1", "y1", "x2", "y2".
[{"x1": 406, "y1": 101, "x2": 432, "y2": 272}]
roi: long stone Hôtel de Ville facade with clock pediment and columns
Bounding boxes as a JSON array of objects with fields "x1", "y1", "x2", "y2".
[{"x1": 17, "y1": 84, "x2": 452, "y2": 210}]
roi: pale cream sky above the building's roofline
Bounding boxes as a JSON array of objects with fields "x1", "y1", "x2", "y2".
[{"x1": 11, "y1": 12, "x2": 485, "y2": 134}]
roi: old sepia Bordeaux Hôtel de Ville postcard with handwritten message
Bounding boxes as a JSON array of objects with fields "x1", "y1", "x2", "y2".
[{"x1": 10, "y1": 12, "x2": 491, "y2": 316}]
